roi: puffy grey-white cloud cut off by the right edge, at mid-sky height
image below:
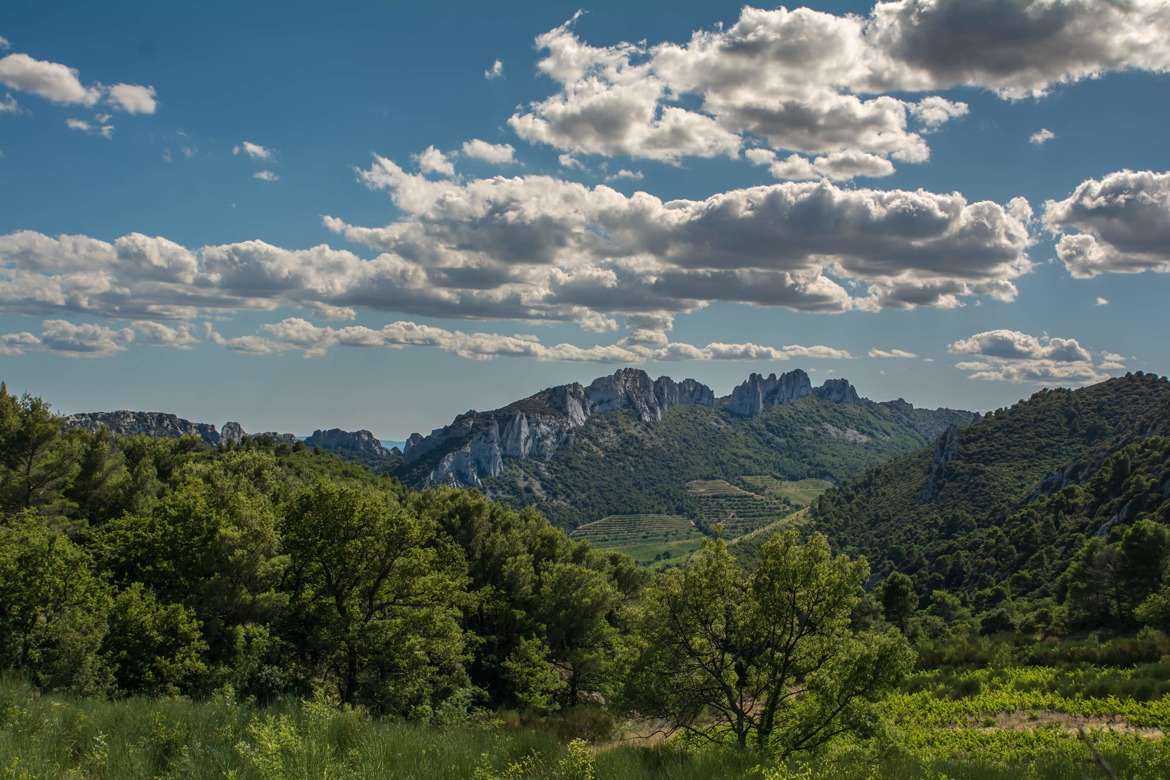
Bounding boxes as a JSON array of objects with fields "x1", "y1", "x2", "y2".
[{"x1": 1044, "y1": 171, "x2": 1170, "y2": 278}]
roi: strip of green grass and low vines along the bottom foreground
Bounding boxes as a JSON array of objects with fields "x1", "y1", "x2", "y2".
[{"x1": 0, "y1": 668, "x2": 1170, "y2": 780}]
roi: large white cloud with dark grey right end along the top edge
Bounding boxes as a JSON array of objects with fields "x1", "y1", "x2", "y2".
[{"x1": 509, "y1": 0, "x2": 1170, "y2": 170}]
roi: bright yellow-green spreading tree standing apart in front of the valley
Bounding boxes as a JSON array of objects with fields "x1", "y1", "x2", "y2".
[{"x1": 626, "y1": 530, "x2": 914, "y2": 755}]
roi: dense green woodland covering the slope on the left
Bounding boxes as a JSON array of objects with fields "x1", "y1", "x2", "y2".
[{"x1": 0, "y1": 386, "x2": 646, "y2": 720}]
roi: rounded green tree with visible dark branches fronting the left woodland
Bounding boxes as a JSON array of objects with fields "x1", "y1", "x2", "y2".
[{"x1": 282, "y1": 482, "x2": 468, "y2": 718}]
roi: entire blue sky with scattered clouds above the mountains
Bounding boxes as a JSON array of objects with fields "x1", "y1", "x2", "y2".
[{"x1": 0, "y1": 0, "x2": 1170, "y2": 439}]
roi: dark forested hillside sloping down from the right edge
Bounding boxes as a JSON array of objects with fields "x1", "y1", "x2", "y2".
[{"x1": 811, "y1": 373, "x2": 1170, "y2": 633}]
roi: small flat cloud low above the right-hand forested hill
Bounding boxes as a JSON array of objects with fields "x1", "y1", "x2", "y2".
[{"x1": 948, "y1": 329, "x2": 1124, "y2": 385}]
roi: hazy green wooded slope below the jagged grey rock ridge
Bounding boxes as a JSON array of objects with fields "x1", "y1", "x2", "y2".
[{"x1": 484, "y1": 396, "x2": 971, "y2": 529}]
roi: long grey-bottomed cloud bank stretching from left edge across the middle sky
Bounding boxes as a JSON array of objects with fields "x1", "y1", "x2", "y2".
[{"x1": 0, "y1": 158, "x2": 1031, "y2": 332}]
